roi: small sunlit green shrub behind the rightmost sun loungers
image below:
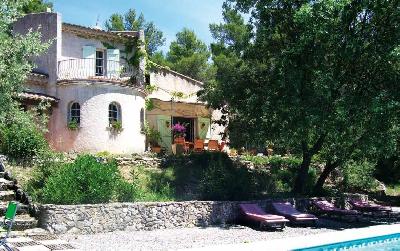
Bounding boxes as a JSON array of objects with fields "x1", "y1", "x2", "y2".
[{"x1": 342, "y1": 160, "x2": 378, "y2": 192}]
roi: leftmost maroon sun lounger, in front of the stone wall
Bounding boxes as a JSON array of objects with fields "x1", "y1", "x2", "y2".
[{"x1": 239, "y1": 204, "x2": 289, "y2": 229}]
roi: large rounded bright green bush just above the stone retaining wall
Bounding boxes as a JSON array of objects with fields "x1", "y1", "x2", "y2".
[{"x1": 43, "y1": 155, "x2": 121, "y2": 204}]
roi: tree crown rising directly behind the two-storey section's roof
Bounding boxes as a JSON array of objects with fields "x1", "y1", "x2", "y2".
[{"x1": 105, "y1": 9, "x2": 165, "y2": 56}]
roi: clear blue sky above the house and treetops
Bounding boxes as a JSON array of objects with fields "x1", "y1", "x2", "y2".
[{"x1": 52, "y1": 0, "x2": 224, "y2": 51}]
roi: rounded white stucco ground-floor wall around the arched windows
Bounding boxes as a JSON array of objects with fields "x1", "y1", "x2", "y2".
[{"x1": 48, "y1": 83, "x2": 145, "y2": 154}]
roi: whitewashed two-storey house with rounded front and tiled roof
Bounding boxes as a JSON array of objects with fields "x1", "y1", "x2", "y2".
[{"x1": 13, "y1": 13, "x2": 223, "y2": 154}]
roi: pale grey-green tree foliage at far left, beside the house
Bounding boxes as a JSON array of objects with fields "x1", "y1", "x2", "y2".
[{"x1": 0, "y1": 0, "x2": 47, "y2": 123}]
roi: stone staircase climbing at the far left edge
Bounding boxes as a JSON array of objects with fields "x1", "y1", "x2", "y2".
[{"x1": 0, "y1": 160, "x2": 45, "y2": 236}]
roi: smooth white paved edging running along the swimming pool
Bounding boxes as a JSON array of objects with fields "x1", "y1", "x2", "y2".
[{"x1": 186, "y1": 224, "x2": 400, "y2": 251}]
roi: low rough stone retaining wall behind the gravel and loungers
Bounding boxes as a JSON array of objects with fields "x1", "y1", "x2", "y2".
[{"x1": 39, "y1": 195, "x2": 365, "y2": 234}]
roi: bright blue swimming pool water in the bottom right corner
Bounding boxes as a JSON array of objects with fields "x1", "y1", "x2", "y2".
[{"x1": 295, "y1": 233, "x2": 400, "y2": 251}]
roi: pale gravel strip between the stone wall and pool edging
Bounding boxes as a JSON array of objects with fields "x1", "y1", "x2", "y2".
[{"x1": 61, "y1": 220, "x2": 362, "y2": 250}]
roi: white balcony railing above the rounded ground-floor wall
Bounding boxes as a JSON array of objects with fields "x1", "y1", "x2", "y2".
[{"x1": 58, "y1": 58, "x2": 138, "y2": 80}]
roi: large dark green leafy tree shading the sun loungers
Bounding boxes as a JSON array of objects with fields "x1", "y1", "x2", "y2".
[{"x1": 201, "y1": 0, "x2": 400, "y2": 193}]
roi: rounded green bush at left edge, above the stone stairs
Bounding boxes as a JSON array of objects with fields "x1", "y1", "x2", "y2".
[{"x1": 0, "y1": 116, "x2": 49, "y2": 161}]
